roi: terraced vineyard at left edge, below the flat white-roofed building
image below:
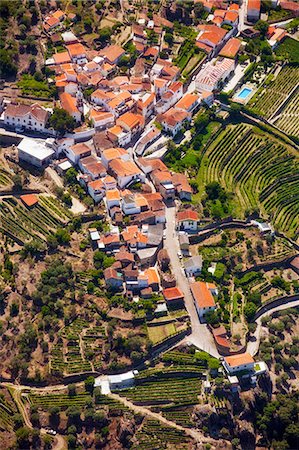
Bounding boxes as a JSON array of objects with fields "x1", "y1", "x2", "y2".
[{"x1": 0, "y1": 195, "x2": 72, "y2": 244}]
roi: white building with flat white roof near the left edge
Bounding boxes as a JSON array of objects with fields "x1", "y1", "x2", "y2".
[{"x1": 17, "y1": 138, "x2": 55, "y2": 168}]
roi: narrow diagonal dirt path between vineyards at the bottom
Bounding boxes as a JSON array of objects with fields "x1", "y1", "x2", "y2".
[{"x1": 108, "y1": 394, "x2": 211, "y2": 443}]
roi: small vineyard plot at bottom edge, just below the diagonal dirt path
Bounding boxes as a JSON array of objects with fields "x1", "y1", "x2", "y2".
[{"x1": 132, "y1": 419, "x2": 190, "y2": 450}]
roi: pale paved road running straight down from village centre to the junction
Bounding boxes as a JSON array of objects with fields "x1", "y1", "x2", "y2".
[{"x1": 164, "y1": 206, "x2": 219, "y2": 358}]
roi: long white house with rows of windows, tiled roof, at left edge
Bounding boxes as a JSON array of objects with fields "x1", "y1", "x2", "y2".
[{"x1": 4, "y1": 103, "x2": 49, "y2": 132}]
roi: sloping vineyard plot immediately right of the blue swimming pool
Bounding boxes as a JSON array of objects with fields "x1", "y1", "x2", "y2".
[{"x1": 248, "y1": 66, "x2": 299, "y2": 119}]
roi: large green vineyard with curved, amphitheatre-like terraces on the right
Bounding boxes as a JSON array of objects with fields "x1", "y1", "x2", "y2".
[{"x1": 198, "y1": 123, "x2": 299, "y2": 238}]
